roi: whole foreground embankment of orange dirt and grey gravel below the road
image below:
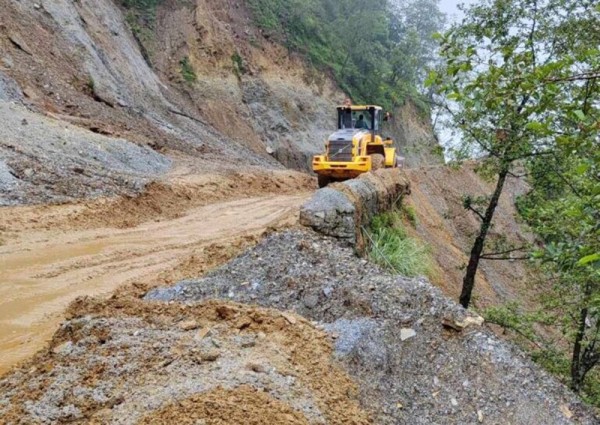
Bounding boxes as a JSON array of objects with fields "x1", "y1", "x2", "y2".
[{"x1": 0, "y1": 231, "x2": 597, "y2": 425}]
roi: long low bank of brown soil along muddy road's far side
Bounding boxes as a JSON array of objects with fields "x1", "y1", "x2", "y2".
[{"x1": 0, "y1": 168, "x2": 316, "y2": 238}]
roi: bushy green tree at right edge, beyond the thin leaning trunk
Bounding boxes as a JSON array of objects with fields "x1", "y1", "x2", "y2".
[{"x1": 520, "y1": 91, "x2": 600, "y2": 395}]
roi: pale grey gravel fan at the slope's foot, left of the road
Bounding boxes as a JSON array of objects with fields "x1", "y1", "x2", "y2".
[{"x1": 0, "y1": 101, "x2": 171, "y2": 206}]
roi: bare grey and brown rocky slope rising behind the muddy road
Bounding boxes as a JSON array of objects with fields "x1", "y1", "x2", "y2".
[{"x1": 0, "y1": 0, "x2": 437, "y2": 205}]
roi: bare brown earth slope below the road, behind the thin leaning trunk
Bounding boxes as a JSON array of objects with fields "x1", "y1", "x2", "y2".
[{"x1": 405, "y1": 164, "x2": 534, "y2": 308}]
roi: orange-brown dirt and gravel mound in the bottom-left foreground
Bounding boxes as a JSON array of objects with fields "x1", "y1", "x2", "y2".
[{"x1": 0, "y1": 299, "x2": 368, "y2": 424}]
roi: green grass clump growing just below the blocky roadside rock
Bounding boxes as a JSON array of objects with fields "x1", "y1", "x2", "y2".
[{"x1": 367, "y1": 209, "x2": 434, "y2": 278}]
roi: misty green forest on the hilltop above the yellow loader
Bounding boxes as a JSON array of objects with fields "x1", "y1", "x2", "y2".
[{"x1": 248, "y1": 0, "x2": 444, "y2": 109}]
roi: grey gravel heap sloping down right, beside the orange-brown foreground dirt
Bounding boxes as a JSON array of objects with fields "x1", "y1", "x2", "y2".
[{"x1": 146, "y1": 231, "x2": 598, "y2": 425}]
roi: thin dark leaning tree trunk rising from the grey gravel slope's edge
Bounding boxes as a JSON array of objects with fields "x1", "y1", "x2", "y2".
[{"x1": 460, "y1": 166, "x2": 508, "y2": 308}]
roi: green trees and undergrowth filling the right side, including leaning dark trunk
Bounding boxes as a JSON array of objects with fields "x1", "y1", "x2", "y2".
[{"x1": 429, "y1": 0, "x2": 600, "y2": 403}]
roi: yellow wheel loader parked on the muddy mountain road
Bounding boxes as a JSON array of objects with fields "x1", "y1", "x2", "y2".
[{"x1": 312, "y1": 105, "x2": 399, "y2": 187}]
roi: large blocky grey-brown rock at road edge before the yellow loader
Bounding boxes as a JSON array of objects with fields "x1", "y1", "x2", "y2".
[{"x1": 300, "y1": 169, "x2": 410, "y2": 243}]
